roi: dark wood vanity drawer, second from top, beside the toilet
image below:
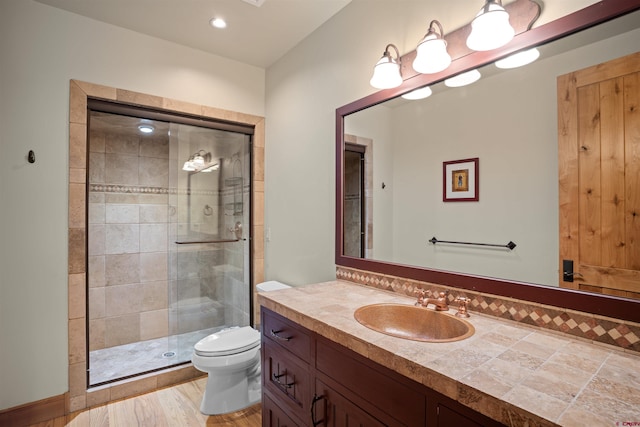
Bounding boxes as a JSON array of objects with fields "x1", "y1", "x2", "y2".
[{"x1": 262, "y1": 339, "x2": 313, "y2": 419}]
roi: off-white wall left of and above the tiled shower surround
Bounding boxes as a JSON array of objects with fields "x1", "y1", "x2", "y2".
[{"x1": 0, "y1": 0, "x2": 265, "y2": 410}]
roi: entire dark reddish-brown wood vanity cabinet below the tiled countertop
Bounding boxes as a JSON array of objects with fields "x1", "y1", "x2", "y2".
[{"x1": 261, "y1": 307, "x2": 502, "y2": 427}]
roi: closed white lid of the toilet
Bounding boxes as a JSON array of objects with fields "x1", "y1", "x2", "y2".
[{"x1": 194, "y1": 326, "x2": 260, "y2": 356}]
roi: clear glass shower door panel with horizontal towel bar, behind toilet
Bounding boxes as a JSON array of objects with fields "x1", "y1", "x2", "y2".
[{"x1": 168, "y1": 124, "x2": 251, "y2": 363}]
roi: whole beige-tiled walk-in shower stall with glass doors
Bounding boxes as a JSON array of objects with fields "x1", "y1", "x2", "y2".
[{"x1": 86, "y1": 100, "x2": 253, "y2": 387}]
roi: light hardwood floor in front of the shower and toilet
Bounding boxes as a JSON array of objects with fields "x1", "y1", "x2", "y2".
[{"x1": 31, "y1": 377, "x2": 262, "y2": 427}]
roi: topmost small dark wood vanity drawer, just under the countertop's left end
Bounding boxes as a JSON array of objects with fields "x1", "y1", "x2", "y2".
[{"x1": 262, "y1": 309, "x2": 311, "y2": 362}]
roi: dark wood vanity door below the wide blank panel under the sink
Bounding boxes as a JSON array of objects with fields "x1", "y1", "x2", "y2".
[{"x1": 311, "y1": 380, "x2": 385, "y2": 427}]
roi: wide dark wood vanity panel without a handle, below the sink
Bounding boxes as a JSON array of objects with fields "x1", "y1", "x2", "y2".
[{"x1": 316, "y1": 340, "x2": 426, "y2": 426}]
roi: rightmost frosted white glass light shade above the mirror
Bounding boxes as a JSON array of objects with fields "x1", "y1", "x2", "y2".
[{"x1": 467, "y1": 0, "x2": 515, "y2": 51}]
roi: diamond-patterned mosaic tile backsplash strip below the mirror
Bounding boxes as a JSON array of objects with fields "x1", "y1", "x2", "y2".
[{"x1": 336, "y1": 267, "x2": 640, "y2": 353}]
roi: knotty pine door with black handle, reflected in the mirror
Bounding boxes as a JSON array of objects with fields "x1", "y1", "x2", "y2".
[{"x1": 558, "y1": 52, "x2": 640, "y2": 298}]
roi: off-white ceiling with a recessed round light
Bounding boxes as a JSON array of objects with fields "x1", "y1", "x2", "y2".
[{"x1": 36, "y1": 0, "x2": 351, "y2": 68}]
